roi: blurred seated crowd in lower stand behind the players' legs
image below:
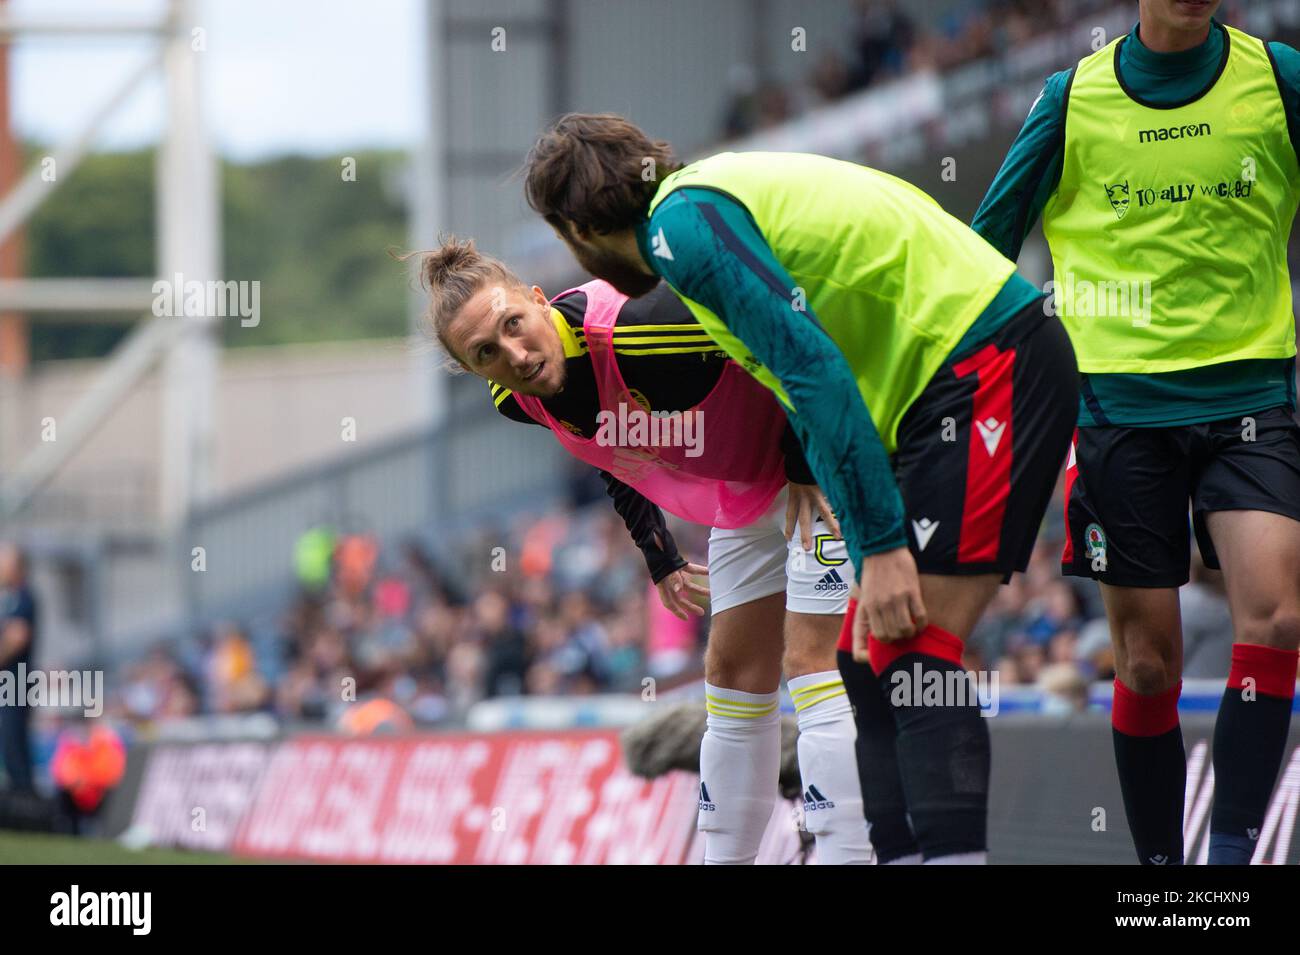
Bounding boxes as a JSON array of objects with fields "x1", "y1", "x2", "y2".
[{"x1": 96, "y1": 470, "x2": 1231, "y2": 729}]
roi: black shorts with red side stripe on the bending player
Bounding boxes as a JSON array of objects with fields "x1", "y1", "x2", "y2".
[{"x1": 892, "y1": 301, "x2": 1079, "y2": 583}]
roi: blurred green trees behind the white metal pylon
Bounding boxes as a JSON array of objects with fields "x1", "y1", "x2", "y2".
[{"x1": 26, "y1": 149, "x2": 407, "y2": 361}]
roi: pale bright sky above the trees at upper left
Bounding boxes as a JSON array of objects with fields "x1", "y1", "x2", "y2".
[{"x1": 9, "y1": 0, "x2": 426, "y2": 160}]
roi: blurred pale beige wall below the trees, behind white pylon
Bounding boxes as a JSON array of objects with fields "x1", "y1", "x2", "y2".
[{"x1": 0, "y1": 339, "x2": 437, "y2": 525}]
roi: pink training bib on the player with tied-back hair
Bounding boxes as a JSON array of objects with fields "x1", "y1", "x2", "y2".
[{"x1": 515, "y1": 281, "x2": 785, "y2": 528}]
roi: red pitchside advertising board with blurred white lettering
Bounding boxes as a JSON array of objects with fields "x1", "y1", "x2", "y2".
[{"x1": 233, "y1": 730, "x2": 697, "y2": 864}]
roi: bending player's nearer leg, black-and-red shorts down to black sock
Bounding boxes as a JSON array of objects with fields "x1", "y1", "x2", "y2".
[{"x1": 854, "y1": 303, "x2": 1078, "y2": 864}]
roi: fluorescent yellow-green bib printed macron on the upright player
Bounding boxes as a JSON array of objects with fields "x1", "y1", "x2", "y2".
[{"x1": 1043, "y1": 27, "x2": 1300, "y2": 374}]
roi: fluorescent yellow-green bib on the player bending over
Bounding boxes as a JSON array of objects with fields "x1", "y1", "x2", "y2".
[{"x1": 650, "y1": 152, "x2": 1015, "y2": 453}]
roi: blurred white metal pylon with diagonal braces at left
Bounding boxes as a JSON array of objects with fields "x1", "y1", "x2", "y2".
[{"x1": 0, "y1": 0, "x2": 221, "y2": 524}]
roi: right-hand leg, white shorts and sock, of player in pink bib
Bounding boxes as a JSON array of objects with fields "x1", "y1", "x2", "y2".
[{"x1": 785, "y1": 520, "x2": 873, "y2": 865}]
